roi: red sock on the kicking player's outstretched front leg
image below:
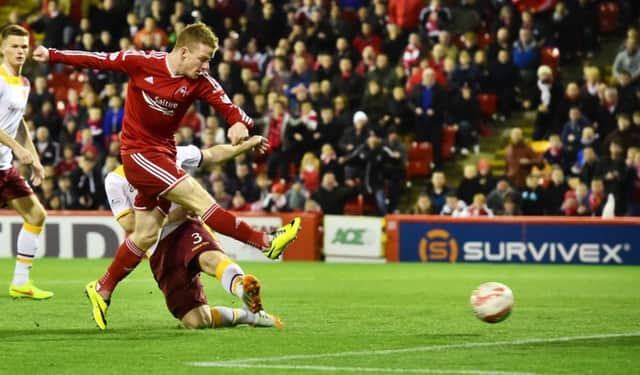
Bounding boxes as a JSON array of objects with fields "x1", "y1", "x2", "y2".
[{"x1": 202, "y1": 203, "x2": 269, "y2": 249}]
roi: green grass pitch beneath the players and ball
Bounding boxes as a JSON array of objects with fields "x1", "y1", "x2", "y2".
[{"x1": 0, "y1": 259, "x2": 640, "y2": 375}]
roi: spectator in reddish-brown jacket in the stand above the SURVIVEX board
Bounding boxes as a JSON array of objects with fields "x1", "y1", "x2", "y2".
[{"x1": 505, "y1": 128, "x2": 541, "y2": 189}]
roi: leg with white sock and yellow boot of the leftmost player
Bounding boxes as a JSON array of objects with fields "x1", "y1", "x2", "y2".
[{"x1": 8, "y1": 194, "x2": 53, "y2": 299}]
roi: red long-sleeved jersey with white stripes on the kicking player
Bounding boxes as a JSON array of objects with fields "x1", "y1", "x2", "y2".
[{"x1": 49, "y1": 49, "x2": 253, "y2": 158}]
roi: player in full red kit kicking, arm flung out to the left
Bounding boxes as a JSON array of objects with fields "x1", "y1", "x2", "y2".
[{"x1": 33, "y1": 22, "x2": 300, "y2": 329}]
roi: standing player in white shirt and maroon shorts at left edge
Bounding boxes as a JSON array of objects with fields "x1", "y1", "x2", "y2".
[{"x1": 0, "y1": 25, "x2": 53, "y2": 299}]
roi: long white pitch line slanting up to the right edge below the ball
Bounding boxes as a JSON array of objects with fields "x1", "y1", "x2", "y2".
[{"x1": 187, "y1": 332, "x2": 640, "y2": 367}]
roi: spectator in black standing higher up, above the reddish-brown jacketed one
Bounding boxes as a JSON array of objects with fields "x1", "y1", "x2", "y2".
[{"x1": 489, "y1": 50, "x2": 520, "y2": 121}]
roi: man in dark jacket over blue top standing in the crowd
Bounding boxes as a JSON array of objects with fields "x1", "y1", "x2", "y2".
[{"x1": 409, "y1": 68, "x2": 447, "y2": 168}]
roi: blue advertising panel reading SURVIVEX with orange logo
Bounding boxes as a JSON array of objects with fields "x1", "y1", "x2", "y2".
[{"x1": 398, "y1": 221, "x2": 640, "y2": 265}]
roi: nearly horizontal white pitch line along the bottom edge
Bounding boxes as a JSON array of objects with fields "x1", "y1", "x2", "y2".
[{"x1": 188, "y1": 362, "x2": 542, "y2": 375}]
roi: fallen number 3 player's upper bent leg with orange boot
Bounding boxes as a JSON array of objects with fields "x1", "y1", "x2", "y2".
[{"x1": 198, "y1": 251, "x2": 262, "y2": 313}]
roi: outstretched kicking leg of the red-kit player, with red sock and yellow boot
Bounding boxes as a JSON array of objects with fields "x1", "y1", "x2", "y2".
[{"x1": 165, "y1": 177, "x2": 300, "y2": 259}]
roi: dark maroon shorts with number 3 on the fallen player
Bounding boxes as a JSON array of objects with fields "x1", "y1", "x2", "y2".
[{"x1": 150, "y1": 220, "x2": 222, "y2": 319}]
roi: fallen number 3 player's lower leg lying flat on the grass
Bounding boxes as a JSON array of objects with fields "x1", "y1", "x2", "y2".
[{"x1": 181, "y1": 305, "x2": 283, "y2": 329}]
